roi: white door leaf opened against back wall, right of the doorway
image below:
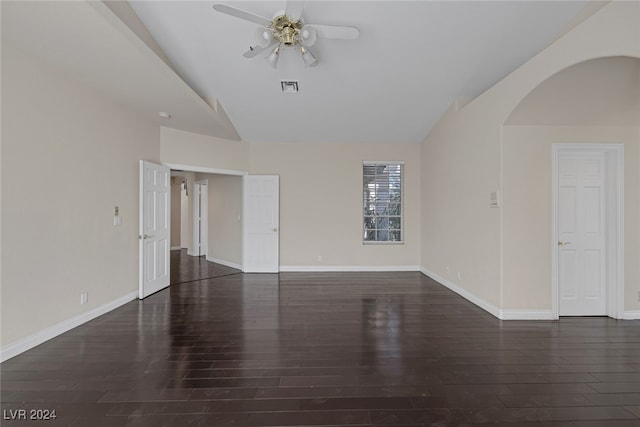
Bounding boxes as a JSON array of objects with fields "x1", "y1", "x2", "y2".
[{"x1": 242, "y1": 175, "x2": 280, "y2": 273}]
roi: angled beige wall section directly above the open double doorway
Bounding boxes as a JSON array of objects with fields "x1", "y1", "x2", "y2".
[{"x1": 160, "y1": 127, "x2": 249, "y2": 172}]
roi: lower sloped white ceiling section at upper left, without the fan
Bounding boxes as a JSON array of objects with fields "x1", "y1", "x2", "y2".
[{"x1": 0, "y1": 0, "x2": 239, "y2": 139}]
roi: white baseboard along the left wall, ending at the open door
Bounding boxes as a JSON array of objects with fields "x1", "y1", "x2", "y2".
[{"x1": 0, "y1": 291, "x2": 138, "y2": 362}]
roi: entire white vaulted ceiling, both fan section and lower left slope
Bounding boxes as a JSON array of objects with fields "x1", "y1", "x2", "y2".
[{"x1": 2, "y1": 0, "x2": 587, "y2": 143}]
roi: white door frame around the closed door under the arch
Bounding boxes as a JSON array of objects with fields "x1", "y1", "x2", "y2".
[{"x1": 551, "y1": 142, "x2": 624, "y2": 320}]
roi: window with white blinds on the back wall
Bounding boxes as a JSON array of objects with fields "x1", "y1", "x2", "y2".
[{"x1": 362, "y1": 162, "x2": 404, "y2": 243}]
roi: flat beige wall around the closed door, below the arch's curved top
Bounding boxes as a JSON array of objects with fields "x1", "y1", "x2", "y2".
[{"x1": 503, "y1": 126, "x2": 640, "y2": 310}]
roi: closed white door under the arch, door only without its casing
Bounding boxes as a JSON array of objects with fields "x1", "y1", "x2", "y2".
[{"x1": 557, "y1": 151, "x2": 607, "y2": 316}]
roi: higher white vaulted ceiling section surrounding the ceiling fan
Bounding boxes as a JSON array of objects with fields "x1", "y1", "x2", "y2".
[{"x1": 130, "y1": 0, "x2": 587, "y2": 143}]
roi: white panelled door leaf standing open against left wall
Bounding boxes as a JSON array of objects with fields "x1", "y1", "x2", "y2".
[{"x1": 139, "y1": 160, "x2": 171, "y2": 299}]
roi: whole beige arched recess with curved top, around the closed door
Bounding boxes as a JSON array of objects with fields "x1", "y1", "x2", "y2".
[{"x1": 501, "y1": 56, "x2": 640, "y2": 318}]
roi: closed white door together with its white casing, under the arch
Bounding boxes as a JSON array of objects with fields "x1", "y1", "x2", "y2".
[{"x1": 552, "y1": 143, "x2": 624, "y2": 318}]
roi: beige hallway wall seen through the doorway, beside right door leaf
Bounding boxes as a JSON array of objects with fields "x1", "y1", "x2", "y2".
[{"x1": 202, "y1": 174, "x2": 242, "y2": 267}]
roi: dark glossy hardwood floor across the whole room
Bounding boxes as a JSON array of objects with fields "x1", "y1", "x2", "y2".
[{"x1": 0, "y1": 252, "x2": 640, "y2": 427}]
